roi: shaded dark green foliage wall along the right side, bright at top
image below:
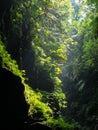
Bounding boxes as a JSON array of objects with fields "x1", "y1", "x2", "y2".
[{"x1": 62, "y1": 1, "x2": 98, "y2": 130}]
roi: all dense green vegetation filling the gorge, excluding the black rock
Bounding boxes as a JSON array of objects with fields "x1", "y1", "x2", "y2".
[{"x1": 0, "y1": 0, "x2": 98, "y2": 130}]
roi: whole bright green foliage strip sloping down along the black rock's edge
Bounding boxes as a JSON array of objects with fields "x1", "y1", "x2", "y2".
[{"x1": 0, "y1": 37, "x2": 52, "y2": 120}]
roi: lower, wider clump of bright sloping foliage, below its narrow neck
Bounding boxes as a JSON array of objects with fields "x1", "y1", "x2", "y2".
[{"x1": 23, "y1": 81, "x2": 53, "y2": 120}]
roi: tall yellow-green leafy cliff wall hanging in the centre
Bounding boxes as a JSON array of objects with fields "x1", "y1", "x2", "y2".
[{"x1": 9, "y1": 0, "x2": 70, "y2": 115}]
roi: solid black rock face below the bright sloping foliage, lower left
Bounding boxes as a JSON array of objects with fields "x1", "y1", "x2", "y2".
[{"x1": 0, "y1": 67, "x2": 28, "y2": 130}]
